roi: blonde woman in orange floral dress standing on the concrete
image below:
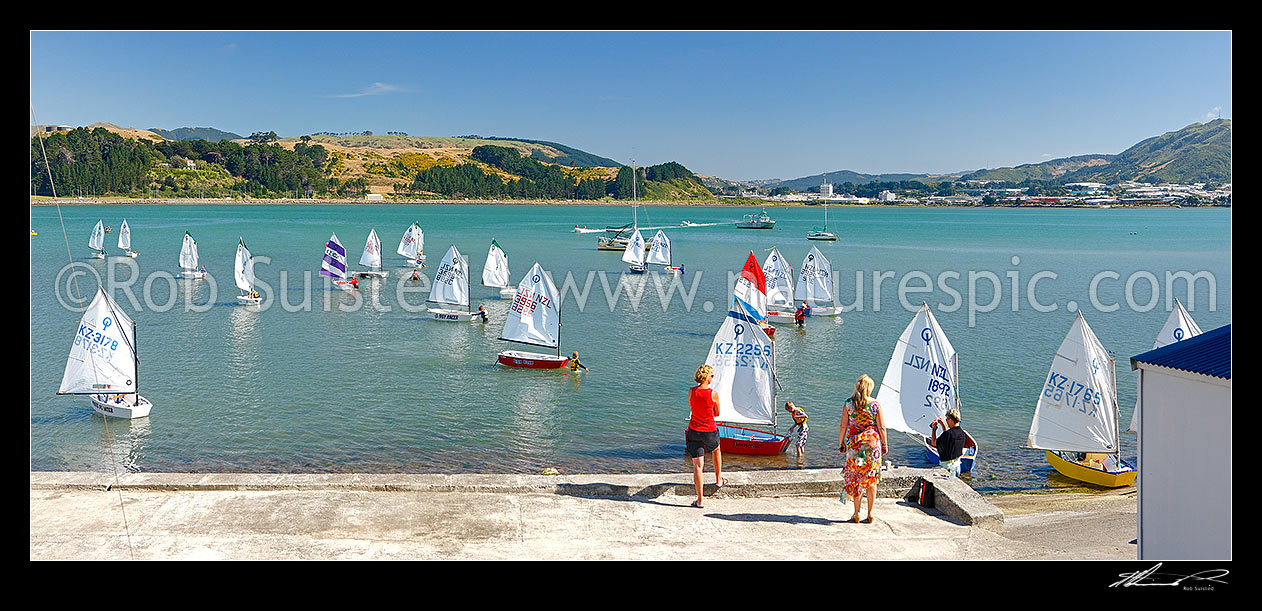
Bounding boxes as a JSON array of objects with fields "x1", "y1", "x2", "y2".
[{"x1": 838, "y1": 375, "x2": 888, "y2": 524}]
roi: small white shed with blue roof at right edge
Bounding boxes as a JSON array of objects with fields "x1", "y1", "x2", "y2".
[{"x1": 1131, "y1": 324, "x2": 1232, "y2": 561}]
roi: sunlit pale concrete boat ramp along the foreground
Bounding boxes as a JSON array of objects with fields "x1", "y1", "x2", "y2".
[{"x1": 30, "y1": 468, "x2": 1136, "y2": 561}]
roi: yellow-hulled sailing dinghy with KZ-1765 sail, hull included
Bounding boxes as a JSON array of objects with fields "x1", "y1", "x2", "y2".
[{"x1": 1026, "y1": 312, "x2": 1136, "y2": 487}]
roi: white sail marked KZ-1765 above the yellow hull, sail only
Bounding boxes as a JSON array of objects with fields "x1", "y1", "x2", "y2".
[{"x1": 1026, "y1": 312, "x2": 1118, "y2": 453}]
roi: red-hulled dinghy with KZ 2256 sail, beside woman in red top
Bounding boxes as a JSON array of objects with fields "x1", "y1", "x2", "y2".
[{"x1": 705, "y1": 299, "x2": 790, "y2": 456}]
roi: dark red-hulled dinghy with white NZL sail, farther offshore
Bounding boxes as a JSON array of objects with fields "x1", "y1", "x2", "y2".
[{"x1": 496, "y1": 263, "x2": 569, "y2": 369}]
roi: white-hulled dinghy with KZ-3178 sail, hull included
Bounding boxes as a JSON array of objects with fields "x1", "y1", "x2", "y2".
[{"x1": 57, "y1": 285, "x2": 153, "y2": 418}]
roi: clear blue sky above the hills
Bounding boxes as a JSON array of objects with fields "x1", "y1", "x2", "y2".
[{"x1": 30, "y1": 32, "x2": 1232, "y2": 179}]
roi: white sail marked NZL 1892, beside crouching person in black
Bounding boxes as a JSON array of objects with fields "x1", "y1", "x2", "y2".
[{"x1": 876, "y1": 304, "x2": 959, "y2": 437}]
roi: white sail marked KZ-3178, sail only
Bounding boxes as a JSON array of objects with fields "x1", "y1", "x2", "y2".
[{"x1": 57, "y1": 287, "x2": 136, "y2": 394}]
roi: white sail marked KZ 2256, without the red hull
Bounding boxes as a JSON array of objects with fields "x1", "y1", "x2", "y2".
[{"x1": 705, "y1": 302, "x2": 776, "y2": 425}]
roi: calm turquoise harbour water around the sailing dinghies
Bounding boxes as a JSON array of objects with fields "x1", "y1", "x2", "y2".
[{"x1": 30, "y1": 205, "x2": 1232, "y2": 491}]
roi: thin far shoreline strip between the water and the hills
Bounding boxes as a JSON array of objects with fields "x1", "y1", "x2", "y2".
[{"x1": 30, "y1": 198, "x2": 1211, "y2": 210}]
